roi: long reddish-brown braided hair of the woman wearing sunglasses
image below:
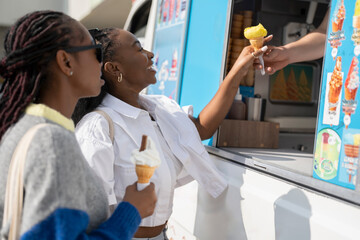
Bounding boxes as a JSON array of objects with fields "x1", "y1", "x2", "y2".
[{"x1": 0, "y1": 11, "x2": 75, "y2": 139}]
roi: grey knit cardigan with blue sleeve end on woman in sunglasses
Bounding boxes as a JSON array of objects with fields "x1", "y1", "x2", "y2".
[{"x1": 0, "y1": 109, "x2": 141, "y2": 240}]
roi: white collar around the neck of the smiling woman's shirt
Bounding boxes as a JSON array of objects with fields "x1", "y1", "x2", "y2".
[{"x1": 101, "y1": 94, "x2": 155, "y2": 118}]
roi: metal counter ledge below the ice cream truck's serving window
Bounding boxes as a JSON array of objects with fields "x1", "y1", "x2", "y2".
[{"x1": 205, "y1": 146, "x2": 360, "y2": 207}]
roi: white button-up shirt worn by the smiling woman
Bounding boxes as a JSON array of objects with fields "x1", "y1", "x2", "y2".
[{"x1": 76, "y1": 94, "x2": 227, "y2": 226}]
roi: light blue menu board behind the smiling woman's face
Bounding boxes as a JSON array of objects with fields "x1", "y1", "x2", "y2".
[{"x1": 147, "y1": 0, "x2": 190, "y2": 101}]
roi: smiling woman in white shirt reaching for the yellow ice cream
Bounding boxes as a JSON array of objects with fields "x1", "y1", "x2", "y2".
[{"x1": 73, "y1": 28, "x2": 268, "y2": 239}]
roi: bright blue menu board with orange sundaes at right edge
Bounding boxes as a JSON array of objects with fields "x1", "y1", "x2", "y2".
[{"x1": 313, "y1": 0, "x2": 360, "y2": 189}]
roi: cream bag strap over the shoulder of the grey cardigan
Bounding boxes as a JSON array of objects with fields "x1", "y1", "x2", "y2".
[{"x1": 2, "y1": 123, "x2": 49, "y2": 240}]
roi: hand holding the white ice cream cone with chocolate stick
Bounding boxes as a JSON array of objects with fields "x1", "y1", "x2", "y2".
[{"x1": 123, "y1": 183, "x2": 157, "y2": 218}]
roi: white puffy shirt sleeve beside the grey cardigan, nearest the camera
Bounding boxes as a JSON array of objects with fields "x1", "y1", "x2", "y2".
[{"x1": 76, "y1": 113, "x2": 117, "y2": 205}]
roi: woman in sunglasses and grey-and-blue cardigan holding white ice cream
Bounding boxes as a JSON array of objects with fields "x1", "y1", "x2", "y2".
[{"x1": 0, "y1": 11, "x2": 156, "y2": 240}]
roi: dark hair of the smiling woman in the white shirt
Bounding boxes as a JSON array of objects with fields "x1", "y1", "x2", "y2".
[{"x1": 71, "y1": 28, "x2": 119, "y2": 124}]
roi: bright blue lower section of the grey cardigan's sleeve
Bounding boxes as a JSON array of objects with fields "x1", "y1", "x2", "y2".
[{"x1": 21, "y1": 202, "x2": 141, "y2": 240}]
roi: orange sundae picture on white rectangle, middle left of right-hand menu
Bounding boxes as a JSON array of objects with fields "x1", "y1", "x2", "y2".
[{"x1": 323, "y1": 57, "x2": 344, "y2": 125}]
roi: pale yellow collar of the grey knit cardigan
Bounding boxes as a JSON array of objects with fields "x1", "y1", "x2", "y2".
[{"x1": 25, "y1": 103, "x2": 75, "y2": 132}]
